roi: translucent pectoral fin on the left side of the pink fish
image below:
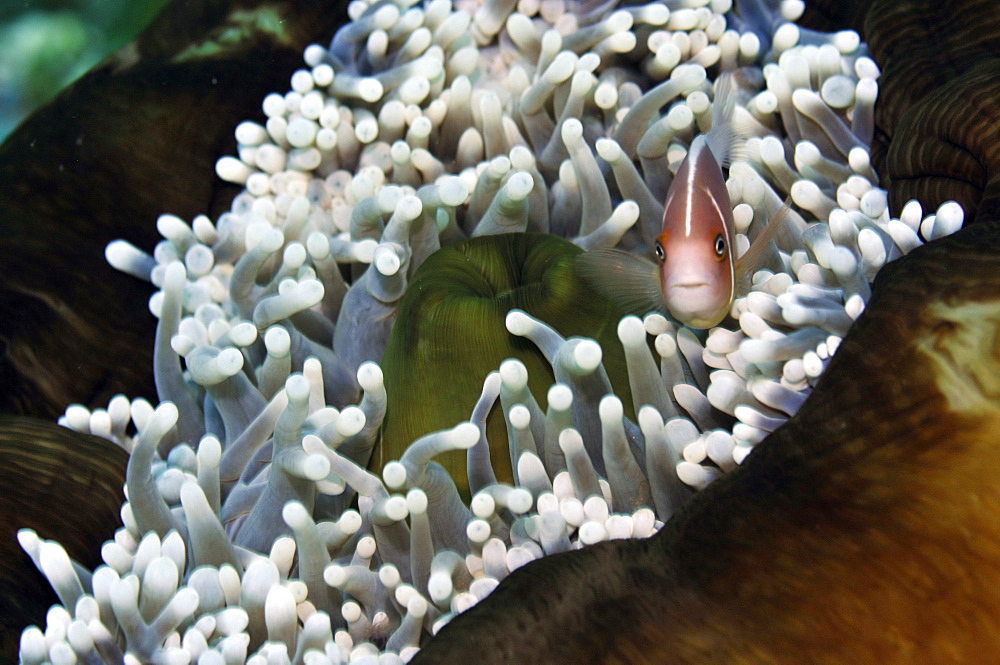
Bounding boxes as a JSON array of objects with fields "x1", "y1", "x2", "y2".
[{"x1": 576, "y1": 249, "x2": 667, "y2": 316}]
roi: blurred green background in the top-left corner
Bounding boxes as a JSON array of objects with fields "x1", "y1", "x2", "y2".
[{"x1": 0, "y1": 0, "x2": 168, "y2": 141}]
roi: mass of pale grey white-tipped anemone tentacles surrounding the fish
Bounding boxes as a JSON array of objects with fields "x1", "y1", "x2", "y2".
[{"x1": 33, "y1": 0, "x2": 962, "y2": 664}]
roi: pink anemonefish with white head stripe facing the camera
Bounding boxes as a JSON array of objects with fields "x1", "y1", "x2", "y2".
[{"x1": 577, "y1": 73, "x2": 788, "y2": 329}]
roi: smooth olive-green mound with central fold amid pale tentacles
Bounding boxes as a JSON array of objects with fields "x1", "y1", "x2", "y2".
[{"x1": 370, "y1": 233, "x2": 631, "y2": 494}]
